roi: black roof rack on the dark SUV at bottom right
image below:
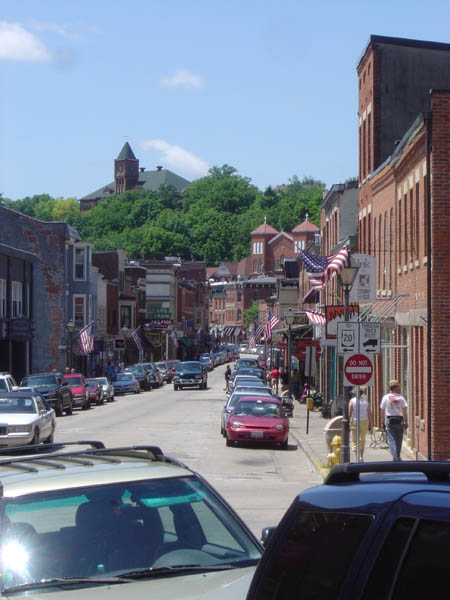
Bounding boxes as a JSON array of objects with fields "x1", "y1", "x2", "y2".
[{"x1": 324, "y1": 460, "x2": 450, "y2": 485}]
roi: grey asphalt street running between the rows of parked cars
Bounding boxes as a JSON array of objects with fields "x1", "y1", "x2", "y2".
[{"x1": 55, "y1": 358, "x2": 322, "y2": 536}]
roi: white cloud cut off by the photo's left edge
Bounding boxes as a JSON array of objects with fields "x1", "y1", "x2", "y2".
[{"x1": 0, "y1": 21, "x2": 52, "y2": 62}]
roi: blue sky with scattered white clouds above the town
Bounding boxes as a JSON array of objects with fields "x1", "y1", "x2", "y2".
[{"x1": 0, "y1": 0, "x2": 450, "y2": 199}]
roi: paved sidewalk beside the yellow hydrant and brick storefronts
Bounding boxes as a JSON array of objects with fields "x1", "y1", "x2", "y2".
[{"x1": 289, "y1": 402, "x2": 394, "y2": 476}]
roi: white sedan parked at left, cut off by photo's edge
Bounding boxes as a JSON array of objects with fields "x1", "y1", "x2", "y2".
[{"x1": 0, "y1": 391, "x2": 56, "y2": 448}]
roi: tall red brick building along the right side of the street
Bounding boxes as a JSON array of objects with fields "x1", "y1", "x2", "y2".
[{"x1": 357, "y1": 36, "x2": 450, "y2": 459}]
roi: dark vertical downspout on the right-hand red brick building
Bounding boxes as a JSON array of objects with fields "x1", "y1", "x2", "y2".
[{"x1": 425, "y1": 111, "x2": 432, "y2": 460}]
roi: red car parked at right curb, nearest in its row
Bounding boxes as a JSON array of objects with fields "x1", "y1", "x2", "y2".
[{"x1": 226, "y1": 396, "x2": 289, "y2": 449}]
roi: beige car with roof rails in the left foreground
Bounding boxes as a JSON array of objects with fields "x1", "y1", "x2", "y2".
[{"x1": 0, "y1": 442, "x2": 262, "y2": 600}]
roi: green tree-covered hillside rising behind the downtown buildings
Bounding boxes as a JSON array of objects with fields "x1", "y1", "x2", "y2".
[{"x1": 2, "y1": 165, "x2": 325, "y2": 265}]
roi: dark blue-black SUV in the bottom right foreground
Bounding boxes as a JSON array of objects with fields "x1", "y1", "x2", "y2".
[{"x1": 247, "y1": 461, "x2": 450, "y2": 600}]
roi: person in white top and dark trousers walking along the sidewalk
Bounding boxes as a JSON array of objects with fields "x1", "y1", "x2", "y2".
[{"x1": 380, "y1": 379, "x2": 408, "y2": 461}]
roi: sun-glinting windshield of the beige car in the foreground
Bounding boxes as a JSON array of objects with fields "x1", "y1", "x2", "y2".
[{"x1": 0, "y1": 477, "x2": 261, "y2": 593}]
